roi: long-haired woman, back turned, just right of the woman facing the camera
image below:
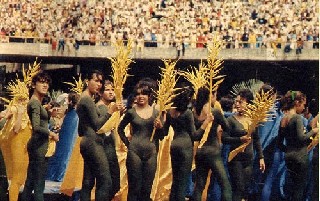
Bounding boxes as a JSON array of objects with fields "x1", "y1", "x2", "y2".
[{"x1": 164, "y1": 86, "x2": 213, "y2": 201}]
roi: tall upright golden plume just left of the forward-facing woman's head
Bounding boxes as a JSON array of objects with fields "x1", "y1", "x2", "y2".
[{"x1": 109, "y1": 40, "x2": 133, "y2": 102}]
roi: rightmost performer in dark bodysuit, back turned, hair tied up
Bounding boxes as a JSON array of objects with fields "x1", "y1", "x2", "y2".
[{"x1": 278, "y1": 91, "x2": 319, "y2": 201}]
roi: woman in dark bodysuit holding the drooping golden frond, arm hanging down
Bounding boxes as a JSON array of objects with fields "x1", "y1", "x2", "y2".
[{"x1": 223, "y1": 89, "x2": 265, "y2": 201}]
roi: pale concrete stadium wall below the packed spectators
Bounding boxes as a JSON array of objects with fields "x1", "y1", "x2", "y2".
[{"x1": 0, "y1": 43, "x2": 319, "y2": 61}]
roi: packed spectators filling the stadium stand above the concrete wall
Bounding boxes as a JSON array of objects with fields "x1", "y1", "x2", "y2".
[{"x1": 0, "y1": 0, "x2": 319, "y2": 49}]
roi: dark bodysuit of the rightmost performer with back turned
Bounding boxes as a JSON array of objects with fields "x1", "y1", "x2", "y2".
[{"x1": 278, "y1": 114, "x2": 315, "y2": 201}]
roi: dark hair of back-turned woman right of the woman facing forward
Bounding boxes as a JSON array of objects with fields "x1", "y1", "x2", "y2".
[{"x1": 172, "y1": 82, "x2": 194, "y2": 112}]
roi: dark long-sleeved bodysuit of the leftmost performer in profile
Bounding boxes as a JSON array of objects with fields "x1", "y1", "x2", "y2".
[{"x1": 22, "y1": 98, "x2": 49, "y2": 201}]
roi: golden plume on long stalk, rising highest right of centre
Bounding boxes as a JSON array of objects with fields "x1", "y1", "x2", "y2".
[{"x1": 198, "y1": 36, "x2": 224, "y2": 148}]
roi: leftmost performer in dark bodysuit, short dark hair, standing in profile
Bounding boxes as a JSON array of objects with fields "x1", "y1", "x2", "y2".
[{"x1": 22, "y1": 73, "x2": 59, "y2": 201}]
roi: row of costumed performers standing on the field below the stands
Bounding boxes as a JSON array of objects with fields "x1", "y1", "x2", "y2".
[{"x1": 0, "y1": 65, "x2": 319, "y2": 201}]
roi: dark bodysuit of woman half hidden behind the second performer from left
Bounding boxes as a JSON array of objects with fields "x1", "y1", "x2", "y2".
[{"x1": 98, "y1": 105, "x2": 120, "y2": 198}]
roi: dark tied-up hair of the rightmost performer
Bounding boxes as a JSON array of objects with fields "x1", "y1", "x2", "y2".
[{"x1": 280, "y1": 90, "x2": 307, "y2": 111}]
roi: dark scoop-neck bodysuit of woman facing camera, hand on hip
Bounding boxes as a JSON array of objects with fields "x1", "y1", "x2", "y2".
[{"x1": 118, "y1": 108, "x2": 160, "y2": 201}]
